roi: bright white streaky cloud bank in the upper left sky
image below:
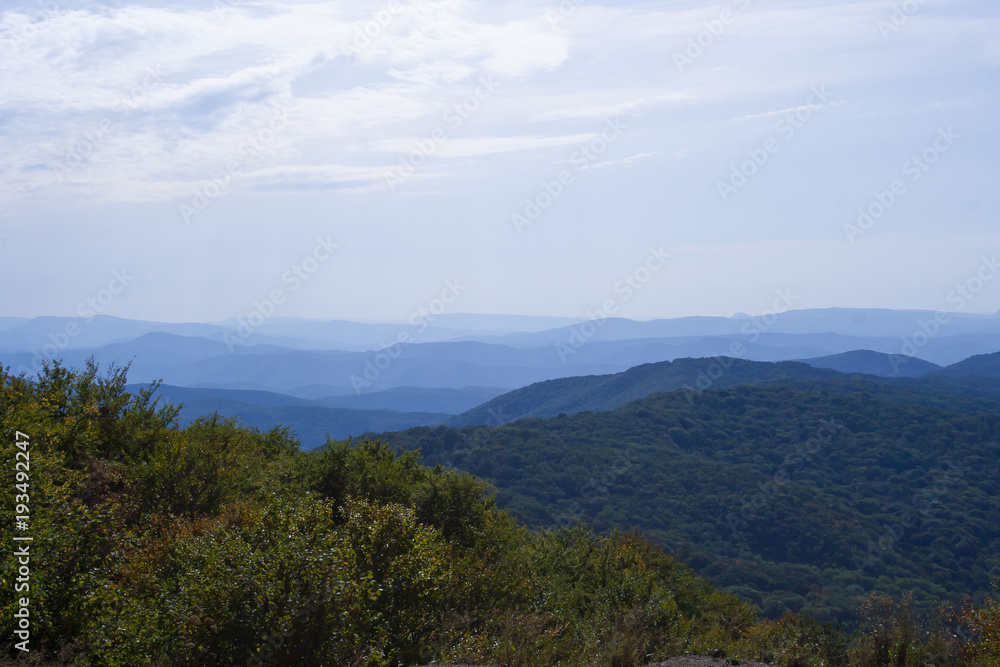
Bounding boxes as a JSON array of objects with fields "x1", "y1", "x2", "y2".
[{"x1": 0, "y1": 0, "x2": 567, "y2": 204}]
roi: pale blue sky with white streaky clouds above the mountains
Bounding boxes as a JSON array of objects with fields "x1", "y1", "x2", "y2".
[{"x1": 0, "y1": 0, "x2": 1000, "y2": 322}]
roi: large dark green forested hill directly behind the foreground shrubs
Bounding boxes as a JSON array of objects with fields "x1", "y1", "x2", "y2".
[{"x1": 381, "y1": 384, "x2": 1000, "y2": 621}]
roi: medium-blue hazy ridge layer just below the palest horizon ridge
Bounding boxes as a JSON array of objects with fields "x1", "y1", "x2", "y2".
[{"x1": 7, "y1": 333, "x2": 1000, "y2": 398}]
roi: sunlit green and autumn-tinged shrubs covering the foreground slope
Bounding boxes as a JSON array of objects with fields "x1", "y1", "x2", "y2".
[{"x1": 0, "y1": 365, "x2": 998, "y2": 667}]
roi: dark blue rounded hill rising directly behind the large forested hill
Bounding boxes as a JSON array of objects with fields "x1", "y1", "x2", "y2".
[{"x1": 445, "y1": 357, "x2": 844, "y2": 427}]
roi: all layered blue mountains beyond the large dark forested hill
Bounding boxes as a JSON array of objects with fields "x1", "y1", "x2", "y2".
[{"x1": 0, "y1": 309, "x2": 1000, "y2": 447}]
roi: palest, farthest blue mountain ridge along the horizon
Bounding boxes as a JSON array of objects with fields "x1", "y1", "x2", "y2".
[{"x1": 7, "y1": 308, "x2": 1000, "y2": 358}]
